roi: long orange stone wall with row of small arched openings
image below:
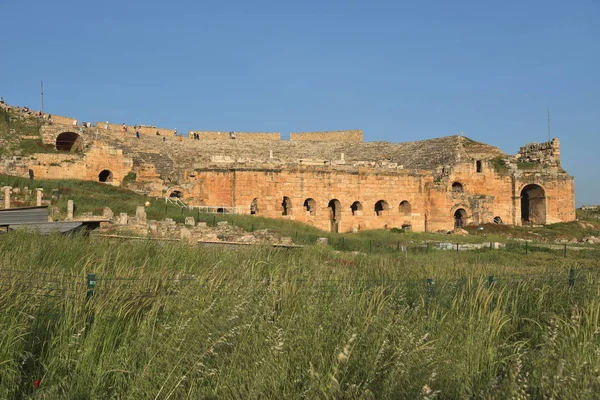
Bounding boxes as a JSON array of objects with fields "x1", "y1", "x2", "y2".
[{"x1": 184, "y1": 167, "x2": 431, "y2": 232}]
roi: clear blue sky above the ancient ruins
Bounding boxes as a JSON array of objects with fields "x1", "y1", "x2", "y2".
[{"x1": 0, "y1": 0, "x2": 600, "y2": 205}]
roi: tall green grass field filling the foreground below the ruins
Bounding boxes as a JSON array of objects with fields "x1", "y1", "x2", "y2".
[{"x1": 0, "y1": 232, "x2": 600, "y2": 399}]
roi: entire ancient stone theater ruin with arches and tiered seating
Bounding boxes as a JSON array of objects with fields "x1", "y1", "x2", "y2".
[{"x1": 0, "y1": 102, "x2": 575, "y2": 232}]
